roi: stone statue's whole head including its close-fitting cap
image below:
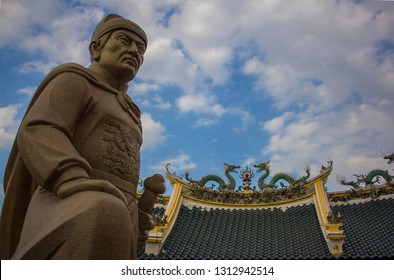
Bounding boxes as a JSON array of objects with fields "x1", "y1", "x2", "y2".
[{"x1": 89, "y1": 14, "x2": 148, "y2": 82}]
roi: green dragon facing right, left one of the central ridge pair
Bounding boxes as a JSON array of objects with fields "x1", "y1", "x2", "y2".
[{"x1": 185, "y1": 163, "x2": 241, "y2": 190}]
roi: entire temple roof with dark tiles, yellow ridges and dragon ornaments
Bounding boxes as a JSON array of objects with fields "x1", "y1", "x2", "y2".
[{"x1": 139, "y1": 162, "x2": 394, "y2": 260}]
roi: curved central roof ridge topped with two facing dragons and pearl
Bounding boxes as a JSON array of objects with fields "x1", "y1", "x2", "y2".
[{"x1": 166, "y1": 161, "x2": 332, "y2": 205}]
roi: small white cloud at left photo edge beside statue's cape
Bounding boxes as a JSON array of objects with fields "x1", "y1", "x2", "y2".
[{"x1": 0, "y1": 105, "x2": 20, "y2": 150}]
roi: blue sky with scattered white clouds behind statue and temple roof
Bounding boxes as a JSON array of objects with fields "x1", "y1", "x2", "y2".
[{"x1": 0, "y1": 0, "x2": 394, "y2": 199}]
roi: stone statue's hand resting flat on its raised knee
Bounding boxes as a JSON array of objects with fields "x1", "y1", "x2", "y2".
[{"x1": 55, "y1": 178, "x2": 129, "y2": 207}]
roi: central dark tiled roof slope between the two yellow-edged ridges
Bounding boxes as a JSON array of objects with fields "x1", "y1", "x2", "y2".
[{"x1": 144, "y1": 204, "x2": 332, "y2": 259}]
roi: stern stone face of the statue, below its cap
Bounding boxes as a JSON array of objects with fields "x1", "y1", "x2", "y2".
[{"x1": 98, "y1": 29, "x2": 146, "y2": 83}]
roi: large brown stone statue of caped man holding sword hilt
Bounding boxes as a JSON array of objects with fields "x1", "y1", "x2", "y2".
[{"x1": 0, "y1": 14, "x2": 165, "y2": 259}]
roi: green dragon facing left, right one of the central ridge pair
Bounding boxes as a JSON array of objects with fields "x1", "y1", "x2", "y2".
[{"x1": 254, "y1": 161, "x2": 310, "y2": 190}]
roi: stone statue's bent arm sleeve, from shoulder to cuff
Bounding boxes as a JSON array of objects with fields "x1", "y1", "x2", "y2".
[{"x1": 17, "y1": 72, "x2": 94, "y2": 192}]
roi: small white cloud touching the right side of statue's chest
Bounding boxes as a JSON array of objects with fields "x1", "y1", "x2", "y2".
[{"x1": 141, "y1": 113, "x2": 167, "y2": 150}]
